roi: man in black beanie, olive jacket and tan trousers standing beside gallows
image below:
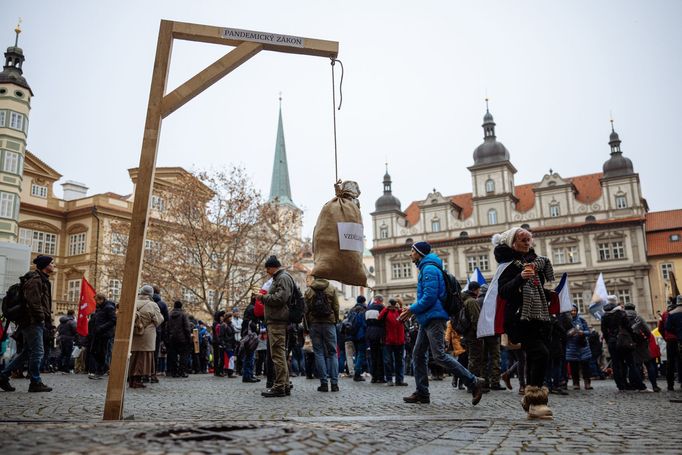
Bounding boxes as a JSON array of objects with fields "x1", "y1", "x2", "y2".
[{"x1": 260, "y1": 256, "x2": 295, "y2": 398}]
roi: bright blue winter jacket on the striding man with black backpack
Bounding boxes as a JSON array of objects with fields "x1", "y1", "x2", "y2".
[{"x1": 410, "y1": 253, "x2": 448, "y2": 326}]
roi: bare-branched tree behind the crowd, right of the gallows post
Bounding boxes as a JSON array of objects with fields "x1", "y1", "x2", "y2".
[{"x1": 104, "y1": 167, "x2": 301, "y2": 314}]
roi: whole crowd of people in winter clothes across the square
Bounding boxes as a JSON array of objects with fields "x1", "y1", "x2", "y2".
[{"x1": 0, "y1": 235, "x2": 682, "y2": 424}]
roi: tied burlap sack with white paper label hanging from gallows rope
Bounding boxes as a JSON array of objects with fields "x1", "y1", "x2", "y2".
[{"x1": 312, "y1": 181, "x2": 367, "y2": 286}]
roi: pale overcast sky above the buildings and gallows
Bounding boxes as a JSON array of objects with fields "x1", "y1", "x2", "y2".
[{"x1": 5, "y1": 0, "x2": 682, "y2": 239}]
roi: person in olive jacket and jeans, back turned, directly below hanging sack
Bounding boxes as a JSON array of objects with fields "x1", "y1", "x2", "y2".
[{"x1": 304, "y1": 278, "x2": 339, "y2": 392}]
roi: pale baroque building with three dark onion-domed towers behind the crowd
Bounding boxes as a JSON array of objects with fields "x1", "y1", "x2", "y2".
[{"x1": 372, "y1": 105, "x2": 654, "y2": 322}]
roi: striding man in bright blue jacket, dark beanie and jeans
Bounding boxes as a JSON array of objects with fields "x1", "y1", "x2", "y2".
[{"x1": 400, "y1": 242, "x2": 484, "y2": 405}]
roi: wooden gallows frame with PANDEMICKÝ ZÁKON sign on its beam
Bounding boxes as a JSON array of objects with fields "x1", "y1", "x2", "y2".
[{"x1": 104, "y1": 20, "x2": 339, "y2": 420}]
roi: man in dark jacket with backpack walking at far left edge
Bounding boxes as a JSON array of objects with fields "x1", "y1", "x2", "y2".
[{"x1": 0, "y1": 255, "x2": 55, "y2": 392}]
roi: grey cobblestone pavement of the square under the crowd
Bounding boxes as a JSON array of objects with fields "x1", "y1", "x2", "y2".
[{"x1": 0, "y1": 375, "x2": 682, "y2": 455}]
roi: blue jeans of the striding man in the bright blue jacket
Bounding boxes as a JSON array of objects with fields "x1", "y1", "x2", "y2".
[{"x1": 412, "y1": 319, "x2": 476, "y2": 396}]
